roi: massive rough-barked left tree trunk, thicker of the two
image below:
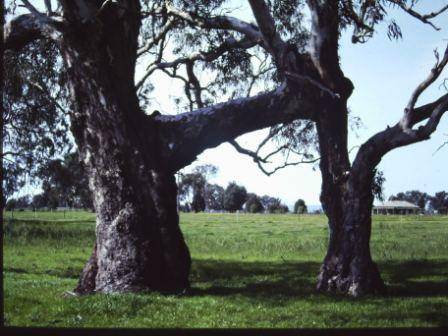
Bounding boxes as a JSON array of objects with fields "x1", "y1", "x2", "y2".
[{"x1": 58, "y1": 2, "x2": 190, "y2": 293}]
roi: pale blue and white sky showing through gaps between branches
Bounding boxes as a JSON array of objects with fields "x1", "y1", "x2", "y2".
[{"x1": 142, "y1": 0, "x2": 448, "y2": 206}]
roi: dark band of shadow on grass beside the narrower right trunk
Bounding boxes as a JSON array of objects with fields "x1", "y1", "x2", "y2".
[{"x1": 191, "y1": 260, "x2": 448, "y2": 300}]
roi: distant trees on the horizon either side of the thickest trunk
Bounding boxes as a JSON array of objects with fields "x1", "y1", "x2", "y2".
[{"x1": 5, "y1": 158, "x2": 308, "y2": 214}]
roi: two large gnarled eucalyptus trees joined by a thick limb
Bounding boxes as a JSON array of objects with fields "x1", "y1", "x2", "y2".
[{"x1": 4, "y1": 0, "x2": 448, "y2": 295}]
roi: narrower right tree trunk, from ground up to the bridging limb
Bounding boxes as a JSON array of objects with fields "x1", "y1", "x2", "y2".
[{"x1": 317, "y1": 101, "x2": 384, "y2": 296}]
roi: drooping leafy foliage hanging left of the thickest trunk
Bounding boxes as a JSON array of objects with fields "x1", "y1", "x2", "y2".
[{"x1": 2, "y1": 36, "x2": 72, "y2": 199}]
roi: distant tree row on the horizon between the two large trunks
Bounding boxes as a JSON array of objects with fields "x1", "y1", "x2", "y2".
[{"x1": 178, "y1": 165, "x2": 307, "y2": 213}]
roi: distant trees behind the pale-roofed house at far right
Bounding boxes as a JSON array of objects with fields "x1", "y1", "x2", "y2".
[{"x1": 389, "y1": 190, "x2": 448, "y2": 215}]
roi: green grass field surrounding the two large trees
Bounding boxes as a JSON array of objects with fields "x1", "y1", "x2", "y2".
[{"x1": 3, "y1": 212, "x2": 448, "y2": 328}]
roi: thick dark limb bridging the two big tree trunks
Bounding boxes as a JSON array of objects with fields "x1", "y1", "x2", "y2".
[{"x1": 155, "y1": 85, "x2": 316, "y2": 171}]
